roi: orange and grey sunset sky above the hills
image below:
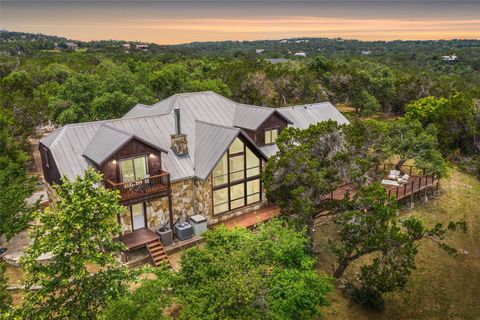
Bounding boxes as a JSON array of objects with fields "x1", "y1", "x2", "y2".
[{"x1": 0, "y1": 0, "x2": 480, "y2": 44}]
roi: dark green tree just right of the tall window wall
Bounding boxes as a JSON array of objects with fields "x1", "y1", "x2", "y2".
[{"x1": 262, "y1": 121, "x2": 368, "y2": 236}]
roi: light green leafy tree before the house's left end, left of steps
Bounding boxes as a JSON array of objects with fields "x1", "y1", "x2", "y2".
[{"x1": 16, "y1": 168, "x2": 129, "y2": 319}]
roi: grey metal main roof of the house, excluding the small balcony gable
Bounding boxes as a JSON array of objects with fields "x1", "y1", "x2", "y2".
[{"x1": 40, "y1": 92, "x2": 348, "y2": 181}]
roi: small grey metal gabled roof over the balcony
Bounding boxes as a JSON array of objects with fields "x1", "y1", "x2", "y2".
[{"x1": 83, "y1": 123, "x2": 167, "y2": 165}]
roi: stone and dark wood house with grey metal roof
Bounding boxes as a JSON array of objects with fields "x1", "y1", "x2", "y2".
[{"x1": 39, "y1": 92, "x2": 348, "y2": 254}]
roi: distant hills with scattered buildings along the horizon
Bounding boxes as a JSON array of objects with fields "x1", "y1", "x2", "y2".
[{"x1": 0, "y1": 30, "x2": 480, "y2": 58}]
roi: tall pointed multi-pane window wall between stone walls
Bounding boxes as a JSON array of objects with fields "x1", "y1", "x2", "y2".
[{"x1": 212, "y1": 138, "x2": 261, "y2": 215}]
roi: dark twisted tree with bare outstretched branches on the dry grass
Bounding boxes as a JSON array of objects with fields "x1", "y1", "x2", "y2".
[{"x1": 331, "y1": 183, "x2": 466, "y2": 307}]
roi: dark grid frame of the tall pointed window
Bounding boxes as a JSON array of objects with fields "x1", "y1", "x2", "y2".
[{"x1": 210, "y1": 136, "x2": 263, "y2": 217}]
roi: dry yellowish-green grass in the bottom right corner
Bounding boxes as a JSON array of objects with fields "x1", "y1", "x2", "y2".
[{"x1": 314, "y1": 169, "x2": 480, "y2": 320}]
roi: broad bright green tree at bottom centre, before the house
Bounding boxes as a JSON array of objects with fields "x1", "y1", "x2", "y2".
[{"x1": 173, "y1": 220, "x2": 332, "y2": 319}]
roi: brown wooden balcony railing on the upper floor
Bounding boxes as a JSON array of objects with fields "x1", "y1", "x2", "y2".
[{"x1": 105, "y1": 171, "x2": 170, "y2": 201}]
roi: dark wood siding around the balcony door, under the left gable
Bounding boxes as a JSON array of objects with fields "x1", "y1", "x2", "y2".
[{"x1": 100, "y1": 139, "x2": 162, "y2": 182}]
